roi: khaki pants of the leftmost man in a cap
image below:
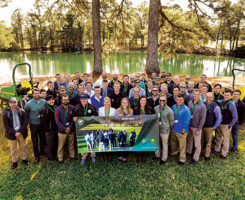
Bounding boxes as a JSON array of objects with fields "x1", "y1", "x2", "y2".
[{"x1": 8, "y1": 134, "x2": 27, "y2": 162}]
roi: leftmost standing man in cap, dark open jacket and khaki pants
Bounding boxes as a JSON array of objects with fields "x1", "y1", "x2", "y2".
[{"x1": 3, "y1": 97, "x2": 30, "y2": 169}]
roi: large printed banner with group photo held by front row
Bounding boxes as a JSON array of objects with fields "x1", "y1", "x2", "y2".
[{"x1": 76, "y1": 115, "x2": 159, "y2": 153}]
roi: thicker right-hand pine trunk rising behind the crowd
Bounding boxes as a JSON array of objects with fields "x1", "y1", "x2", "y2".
[{"x1": 145, "y1": 0, "x2": 161, "y2": 75}]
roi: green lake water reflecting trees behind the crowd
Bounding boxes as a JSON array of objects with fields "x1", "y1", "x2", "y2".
[{"x1": 0, "y1": 52, "x2": 245, "y2": 83}]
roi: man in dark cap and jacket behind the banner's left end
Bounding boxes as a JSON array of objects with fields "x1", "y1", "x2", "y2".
[{"x1": 73, "y1": 93, "x2": 98, "y2": 165}]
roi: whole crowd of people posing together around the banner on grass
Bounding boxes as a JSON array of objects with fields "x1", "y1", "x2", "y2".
[{"x1": 3, "y1": 71, "x2": 245, "y2": 169}]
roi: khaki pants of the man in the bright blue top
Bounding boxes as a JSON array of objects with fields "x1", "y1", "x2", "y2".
[{"x1": 171, "y1": 132, "x2": 187, "y2": 162}]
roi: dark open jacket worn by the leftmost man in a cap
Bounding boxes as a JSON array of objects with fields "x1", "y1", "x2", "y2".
[{"x1": 3, "y1": 108, "x2": 28, "y2": 140}]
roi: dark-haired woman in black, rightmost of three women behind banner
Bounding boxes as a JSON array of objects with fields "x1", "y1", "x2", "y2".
[{"x1": 134, "y1": 95, "x2": 155, "y2": 162}]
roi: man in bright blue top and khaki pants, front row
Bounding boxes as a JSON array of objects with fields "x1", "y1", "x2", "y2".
[{"x1": 171, "y1": 95, "x2": 191, "y2": 165}]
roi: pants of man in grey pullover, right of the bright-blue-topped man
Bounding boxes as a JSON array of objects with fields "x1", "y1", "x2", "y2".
[{"x1": 187, "y1": 127, "x2": 202, "y2": 161}]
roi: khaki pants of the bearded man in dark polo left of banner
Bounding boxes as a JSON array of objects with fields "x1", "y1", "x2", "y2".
[{"x1": 57, "y1": 133, "x2": 75, "y2": 161}]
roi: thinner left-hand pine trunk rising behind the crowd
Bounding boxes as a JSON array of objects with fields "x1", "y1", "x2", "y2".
[{"x1": 92, "y1": 0, "x2": 103, "y2": 75}]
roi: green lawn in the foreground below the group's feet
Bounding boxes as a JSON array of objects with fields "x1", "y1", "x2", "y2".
[{"x1": 0, "y1": 115, "x2": 245, "y2": 200}]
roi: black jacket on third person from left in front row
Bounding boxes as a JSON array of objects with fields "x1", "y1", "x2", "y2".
[{"x1": 40, "y1": 104, "x2": 58, "y2": 133}]
